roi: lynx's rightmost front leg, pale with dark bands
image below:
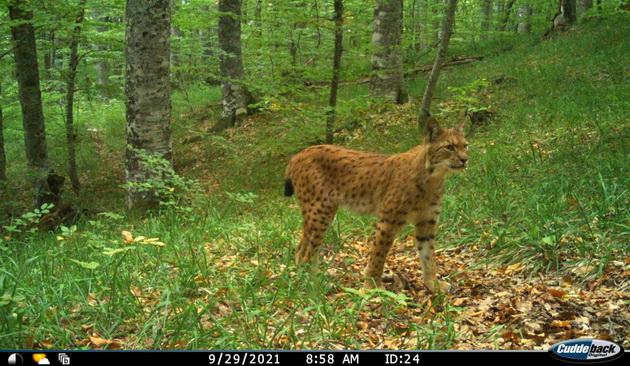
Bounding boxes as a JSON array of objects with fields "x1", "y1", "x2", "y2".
[{"x1": 416, "y1": 216, "x2": 450, "y2": 292}]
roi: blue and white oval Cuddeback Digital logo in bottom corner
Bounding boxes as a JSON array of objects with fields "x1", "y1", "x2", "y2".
[{"x1": 549, "y1": 339, "x2": 623, "y2": 363}]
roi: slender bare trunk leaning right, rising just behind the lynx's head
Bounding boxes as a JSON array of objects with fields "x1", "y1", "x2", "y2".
[{"x1": 418, "y1": 0, "x2": 457, "y2": 131}]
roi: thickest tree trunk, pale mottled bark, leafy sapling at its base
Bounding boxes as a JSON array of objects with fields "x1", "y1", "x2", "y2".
[{"x1": 125, "y1": 0, "x2": 172, "y2": 211}]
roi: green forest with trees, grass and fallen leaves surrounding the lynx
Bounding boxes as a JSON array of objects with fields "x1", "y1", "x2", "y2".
[{"x1": 0, "y1": 0, "x2": 630, "y2": 350}]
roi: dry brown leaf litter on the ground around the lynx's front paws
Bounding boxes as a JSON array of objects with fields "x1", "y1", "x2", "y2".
[{"x1": 194, "y1": 235, "x2": 630, "y2": 350}]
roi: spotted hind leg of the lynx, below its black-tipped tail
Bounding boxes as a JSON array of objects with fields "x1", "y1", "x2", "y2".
[{"x1": 295, "y1": 200, "x2": 337, "y2": 266}]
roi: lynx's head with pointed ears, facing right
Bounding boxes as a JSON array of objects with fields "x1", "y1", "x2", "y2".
[{"x1": 424, "y1": 117, "x2": 468, "y2": 173}]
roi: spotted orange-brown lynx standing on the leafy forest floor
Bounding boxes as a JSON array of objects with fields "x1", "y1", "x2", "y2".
[{"x1": 284, "y1": 117, "x2": 468, "y2": 292}]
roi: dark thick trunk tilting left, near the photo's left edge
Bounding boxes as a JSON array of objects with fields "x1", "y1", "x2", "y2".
[{"x1": 9, "y1": 0, "x2": 55, "y2": 207}]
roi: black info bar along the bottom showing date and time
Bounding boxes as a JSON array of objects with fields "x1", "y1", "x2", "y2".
[{"x1": 0, "y1": 350, "x2": 630, "y2": 366}]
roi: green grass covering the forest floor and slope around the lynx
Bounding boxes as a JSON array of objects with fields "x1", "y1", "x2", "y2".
[{"x1": 0, "y1": 16, "x2": 630, "y2": 349}]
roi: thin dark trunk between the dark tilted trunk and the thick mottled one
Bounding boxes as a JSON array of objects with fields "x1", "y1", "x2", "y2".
[{"x1": 66, "y1": 0, "x2": 86, "y2": 193}]
